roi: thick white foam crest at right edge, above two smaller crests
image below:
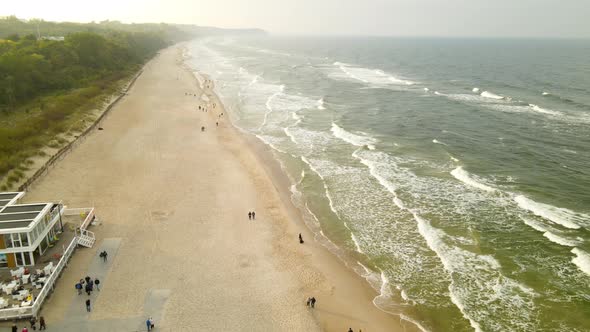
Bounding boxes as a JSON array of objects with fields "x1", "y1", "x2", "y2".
[{"x1": 514, "y1": 195, "x2": 590, "y2": 229}]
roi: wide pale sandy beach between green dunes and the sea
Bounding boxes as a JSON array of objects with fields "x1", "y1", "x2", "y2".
[{"x1": 19, "y1": 46, "x2": 414, "y2": 332}]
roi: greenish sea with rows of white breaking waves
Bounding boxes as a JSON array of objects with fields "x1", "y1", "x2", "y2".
[{"x1": 186, "y1": 36, "x2": 590, "y2": 331}]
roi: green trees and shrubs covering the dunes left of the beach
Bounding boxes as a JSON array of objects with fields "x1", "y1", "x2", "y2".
[{"x1": 0, "y1": 17, "x2": 199, "y2": 188}]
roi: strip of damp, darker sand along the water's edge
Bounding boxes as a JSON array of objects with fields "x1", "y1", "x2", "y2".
[{"x1": 181, "y1": 45, "x2": 420, "y2": 331}]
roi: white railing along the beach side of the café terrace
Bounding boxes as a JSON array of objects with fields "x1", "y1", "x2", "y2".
[{"x1": 0, "y1": 237, "x2": 78, "y2": 320}]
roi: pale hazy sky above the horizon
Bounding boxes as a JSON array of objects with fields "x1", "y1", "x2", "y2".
[{"x1": 0, "y1": 0, "x2": 590, "y2": 38}]
